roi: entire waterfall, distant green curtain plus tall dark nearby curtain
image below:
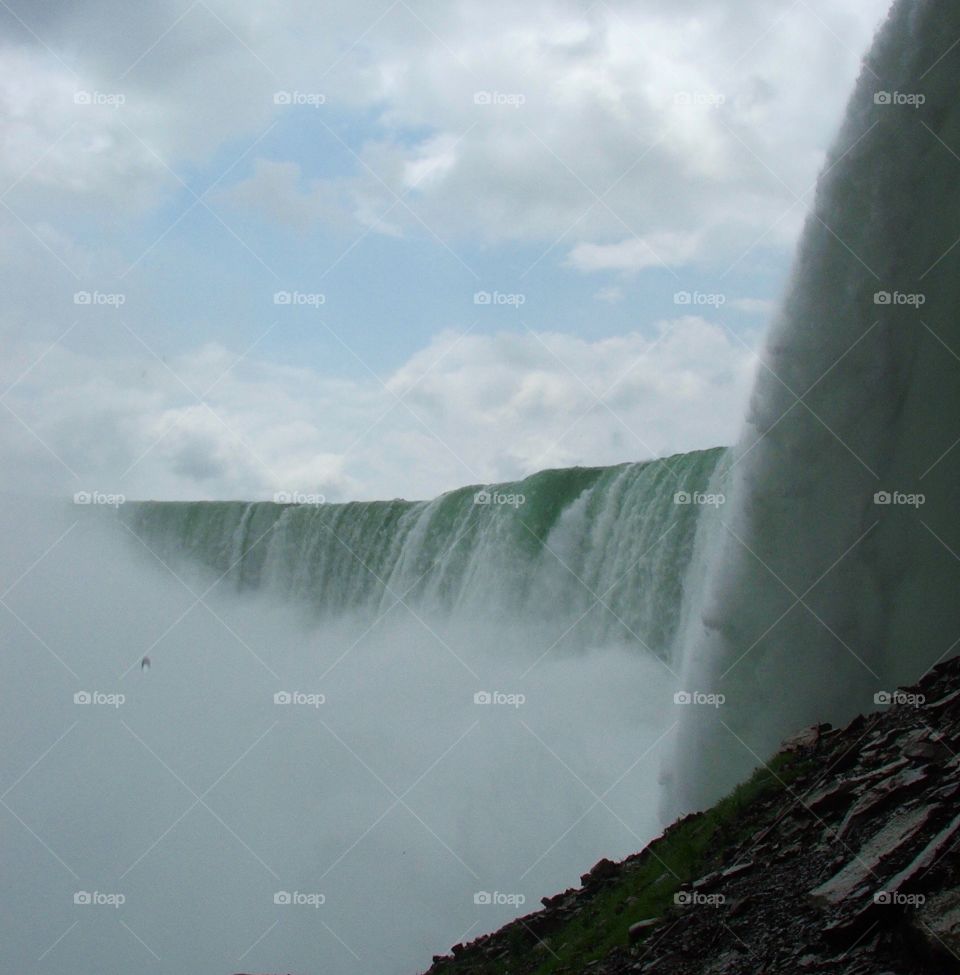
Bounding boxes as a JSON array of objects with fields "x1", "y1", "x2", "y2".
[{"x1": 112, "y1": 0, "x2": 960, "y2": 856}]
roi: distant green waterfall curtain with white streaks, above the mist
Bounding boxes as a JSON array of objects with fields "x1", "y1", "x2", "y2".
[{"x1": 127, "y1": 448, "x2": 726, "y2": 661}]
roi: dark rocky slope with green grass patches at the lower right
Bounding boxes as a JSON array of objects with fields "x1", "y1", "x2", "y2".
[{"x1": 420, "y1": 657, "x2": 960, "y2": 975}]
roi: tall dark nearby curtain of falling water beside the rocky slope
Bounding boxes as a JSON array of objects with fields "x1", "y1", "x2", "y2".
[{"x1": 665, "y1": 0, "x2": 960, "y2": 811}]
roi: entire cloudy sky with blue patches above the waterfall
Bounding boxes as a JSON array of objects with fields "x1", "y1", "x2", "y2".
[{"x1": 0, "y1": 0, "x2": 888, "y2": 500}]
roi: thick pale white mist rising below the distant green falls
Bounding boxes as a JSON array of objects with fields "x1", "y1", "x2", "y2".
[{"x1": 0, "y1": 500, "x2": 672, "y2": 975}]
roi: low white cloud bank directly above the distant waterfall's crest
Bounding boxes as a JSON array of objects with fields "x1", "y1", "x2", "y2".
[{"x1": 0, "y1": 317, "x2": 753, "y2": 500}]
